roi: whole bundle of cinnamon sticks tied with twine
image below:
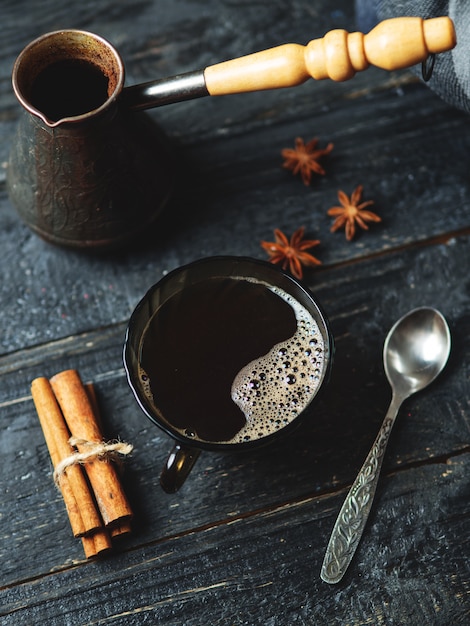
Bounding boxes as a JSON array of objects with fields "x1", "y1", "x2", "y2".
[{"x1": 31, "y1": 369, "x2": 132, "y2": 558}]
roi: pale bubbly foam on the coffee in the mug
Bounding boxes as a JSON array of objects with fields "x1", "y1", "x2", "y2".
[{"x1": 226, "y1": 287, "x2": 325, "y2": 443}]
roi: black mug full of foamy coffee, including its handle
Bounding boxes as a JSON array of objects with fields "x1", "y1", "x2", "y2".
[{"x1": 124, "y1": 257, "x2": 333, "y2": 493}]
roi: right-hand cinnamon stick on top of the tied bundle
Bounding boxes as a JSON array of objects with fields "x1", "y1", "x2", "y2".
[{"x1": 50, "y1": 370, "x2": 132, "y2": 526}]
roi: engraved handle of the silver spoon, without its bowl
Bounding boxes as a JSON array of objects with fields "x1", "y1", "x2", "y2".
[{"x1": 320, "y1": 394, "x2": 405, "y2": 584}]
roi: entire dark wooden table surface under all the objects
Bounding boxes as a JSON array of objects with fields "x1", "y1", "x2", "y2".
[{"x1": 0, "y1": 0, "x2": 470, "y2": 626}]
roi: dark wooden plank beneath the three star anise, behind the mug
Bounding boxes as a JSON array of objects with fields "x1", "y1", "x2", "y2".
[{"x1": 0, "y1": 75, "x2": 470, "y2": 353}]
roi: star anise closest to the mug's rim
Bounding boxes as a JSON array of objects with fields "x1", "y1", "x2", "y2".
[{"x1": 261, "y1": 226, "x2": 321, "y2": 278}]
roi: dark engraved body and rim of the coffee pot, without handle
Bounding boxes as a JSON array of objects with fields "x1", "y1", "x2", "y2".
[{"x1": 7, "y1": 31, "x2": 174, "y2": 248}]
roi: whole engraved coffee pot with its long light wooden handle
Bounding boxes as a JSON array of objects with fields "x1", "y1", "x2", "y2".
[{"x1": 7, "y1": 17, "x2": 456, "y2": 248}]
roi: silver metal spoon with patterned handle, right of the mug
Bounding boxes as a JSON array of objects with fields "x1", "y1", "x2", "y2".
[{"x1": 320, "y1": 308, "x2": 450, "y2": 583}]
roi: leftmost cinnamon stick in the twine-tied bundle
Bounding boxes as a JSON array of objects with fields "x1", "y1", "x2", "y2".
[{"x1": 31, "y1": 377, "x2": 102, "y2": 537}]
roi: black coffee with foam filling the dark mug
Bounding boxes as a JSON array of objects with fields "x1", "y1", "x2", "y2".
[{"x1": 139, "y1": 277, "x2": 325, "y2": 444}]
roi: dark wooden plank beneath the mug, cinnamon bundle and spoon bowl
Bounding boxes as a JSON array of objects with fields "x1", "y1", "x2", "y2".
[{"x1": 0, "y1": 238, "x2": 470, "y2": 582}]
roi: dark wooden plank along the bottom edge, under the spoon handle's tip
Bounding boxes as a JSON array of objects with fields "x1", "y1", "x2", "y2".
[{"x1": 1, "y1": 454, "x2": 470, "y2": 626}]
